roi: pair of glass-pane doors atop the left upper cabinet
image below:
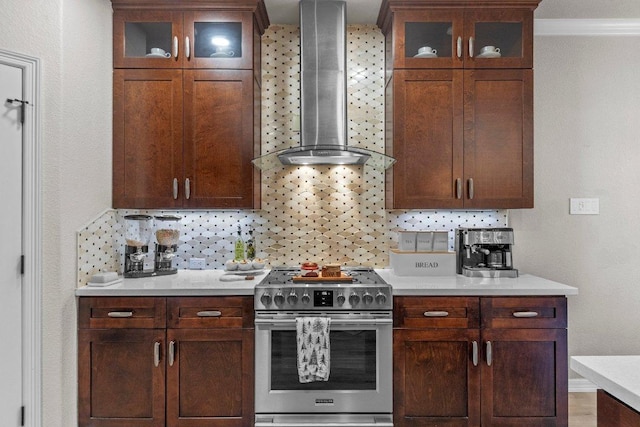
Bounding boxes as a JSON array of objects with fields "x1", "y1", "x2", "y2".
[{"x1": 113, "y1": 10, "x2": 253, "y2": 69}]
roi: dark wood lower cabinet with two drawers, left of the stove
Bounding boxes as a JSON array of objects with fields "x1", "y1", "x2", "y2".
[{"x1": 78, "y1": 297, "x2": 254, "y2": 427}]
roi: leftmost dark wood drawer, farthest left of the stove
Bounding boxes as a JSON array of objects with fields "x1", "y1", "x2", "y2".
[{"x1": 78, "y1": 297, "x2": 166, "y2": 329}]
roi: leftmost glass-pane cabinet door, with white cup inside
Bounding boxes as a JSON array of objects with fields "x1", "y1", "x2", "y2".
[{"x1": 113, "y1": 11, "x2": 182, "y2": 68}]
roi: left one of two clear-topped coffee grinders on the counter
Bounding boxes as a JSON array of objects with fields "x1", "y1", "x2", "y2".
[{"x1": 124, "y1": 215, "x2": 153, "y2": 277}]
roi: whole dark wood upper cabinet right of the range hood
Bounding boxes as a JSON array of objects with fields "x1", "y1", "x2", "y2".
[{"x1": 378, "y1": 0, "x2": 538, "y2": 209}]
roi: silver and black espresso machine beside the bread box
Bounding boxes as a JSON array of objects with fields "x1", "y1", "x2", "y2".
[{"x1": 455, "y1": 228, "x2": 518, "y2": 277}]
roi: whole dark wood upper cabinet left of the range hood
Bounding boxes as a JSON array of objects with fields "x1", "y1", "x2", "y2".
[{"x1": 112, "y1": 0, "x2": 268, "y2": 209}]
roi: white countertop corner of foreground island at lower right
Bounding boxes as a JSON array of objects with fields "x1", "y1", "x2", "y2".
[{"x1": 570, "y1": 356, "x2": 640, "y2": 412}]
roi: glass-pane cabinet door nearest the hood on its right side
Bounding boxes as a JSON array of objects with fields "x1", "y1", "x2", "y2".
[{"x1": 394, "y1": 11, "x2": 463, "y2": 68}]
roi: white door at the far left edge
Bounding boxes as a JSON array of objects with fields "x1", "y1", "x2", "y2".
[{"x1": 0, "y1": 63, "x2": 23, "y2": 427}]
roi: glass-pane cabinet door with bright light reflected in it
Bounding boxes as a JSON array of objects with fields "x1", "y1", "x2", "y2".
[{"x1": 185, "y1": 11, "x2": 253, "y2": 69}]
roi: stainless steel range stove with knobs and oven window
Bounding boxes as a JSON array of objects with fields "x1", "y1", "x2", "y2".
[{"x1": 255, "y1": 267, "x2": 393, "y2": 427}]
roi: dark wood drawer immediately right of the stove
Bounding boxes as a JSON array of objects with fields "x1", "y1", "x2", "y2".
[{"x1": 393, "y1": 297, "x2": 480, "y2": 329}]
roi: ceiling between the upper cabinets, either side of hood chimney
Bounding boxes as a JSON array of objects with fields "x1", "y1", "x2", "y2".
[{"x1": 264, "y1": 0, "x2": 382, "y2": 25}]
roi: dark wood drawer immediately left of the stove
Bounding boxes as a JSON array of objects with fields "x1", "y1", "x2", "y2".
[{"x1": 167, "y1": 297, "x2": 253, "y2": 329}]
